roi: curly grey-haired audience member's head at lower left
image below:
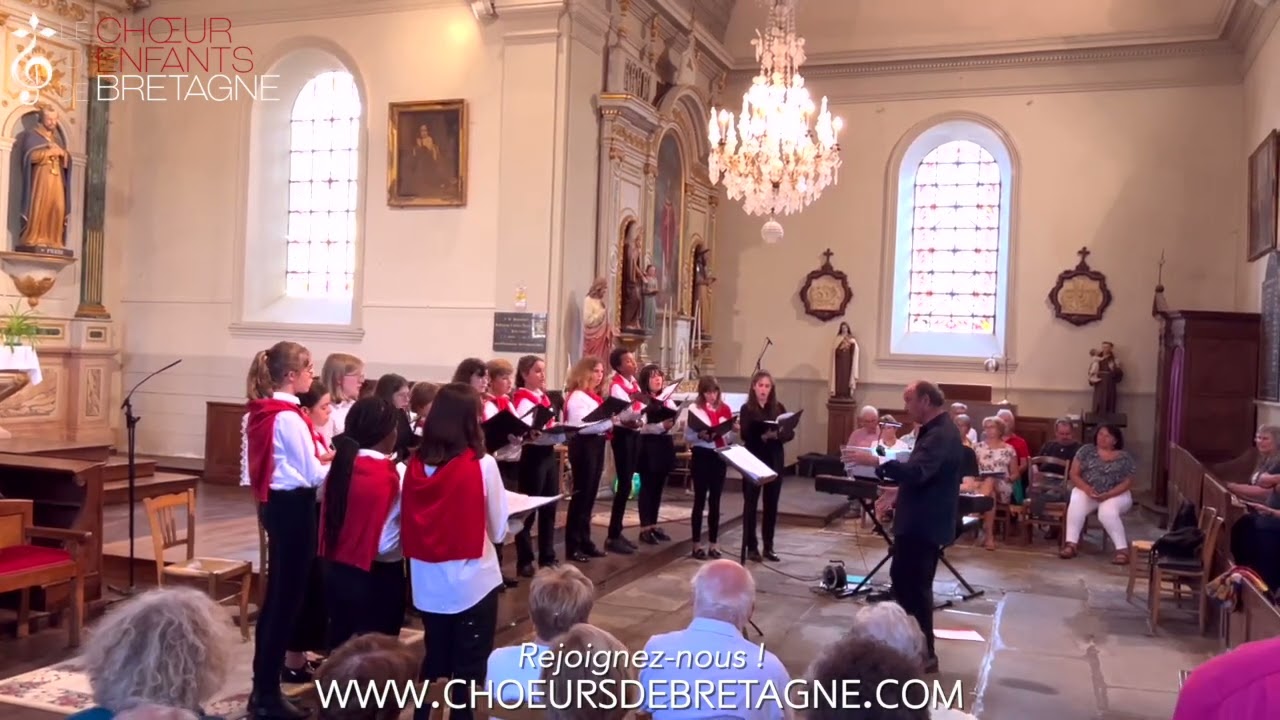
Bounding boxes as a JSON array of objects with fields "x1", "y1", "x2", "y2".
[{"x1": 72, "y1": 587, "x2": 236, "y2": 720}]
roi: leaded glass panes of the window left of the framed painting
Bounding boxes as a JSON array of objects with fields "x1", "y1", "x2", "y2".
[{"x1": 284, "y1": 72, "x2": 361, "y2": 299}]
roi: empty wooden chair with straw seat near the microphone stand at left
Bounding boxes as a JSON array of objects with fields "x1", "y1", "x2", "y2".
[{"x1": 142, "y1": 489, "x2": 253, "y2": 632}]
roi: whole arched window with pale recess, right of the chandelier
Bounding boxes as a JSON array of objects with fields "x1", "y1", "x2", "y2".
[{"x1": 890, "y1": 120, "x2": 1014, "y2": 359}]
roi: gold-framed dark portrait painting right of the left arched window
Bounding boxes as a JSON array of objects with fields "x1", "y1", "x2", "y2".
[{"x1": 387, "y1": 100, "x2": 467, "y2": 208}]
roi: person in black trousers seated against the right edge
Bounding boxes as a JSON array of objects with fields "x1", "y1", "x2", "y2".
[{"x1": 1226, "y1": 425, "x2": 1280, "y2": 593}]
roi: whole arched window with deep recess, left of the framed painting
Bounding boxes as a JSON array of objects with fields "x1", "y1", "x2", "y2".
[{"x1": 232, "y1": 47, "x2": 366, "y2": 341}]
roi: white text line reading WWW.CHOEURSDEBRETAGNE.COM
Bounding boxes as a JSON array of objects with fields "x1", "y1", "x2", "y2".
[{"x1": 315, "y1": 678, "x2": 964, "y2": 711}]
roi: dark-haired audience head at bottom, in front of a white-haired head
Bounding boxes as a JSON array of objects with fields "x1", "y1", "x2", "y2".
[{"x1": 805, "y1": 633, "x2": 929, "y2": 720}]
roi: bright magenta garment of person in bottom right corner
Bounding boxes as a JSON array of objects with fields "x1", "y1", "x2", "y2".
[{"x1": 1172, "y1": 638, "x2": 1280, "y2": 720}]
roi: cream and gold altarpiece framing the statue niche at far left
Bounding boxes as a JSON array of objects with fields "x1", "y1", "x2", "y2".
[{"x1": 0, "y1": 0, "x2": 124, "y2": 442}]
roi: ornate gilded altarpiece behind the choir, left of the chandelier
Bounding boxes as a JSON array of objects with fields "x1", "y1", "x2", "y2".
[{"x1": 596, "y1": 3, "x2": 723, "y2": 379}]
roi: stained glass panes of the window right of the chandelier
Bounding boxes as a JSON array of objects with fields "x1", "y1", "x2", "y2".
[{"x1": 908, "y1": 140, "x2": 1001, "y2": 334}]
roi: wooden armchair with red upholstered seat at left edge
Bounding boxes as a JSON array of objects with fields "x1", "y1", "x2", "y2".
[{"x1": 0, "y1": 500, "x2": 90, "y2": 647}]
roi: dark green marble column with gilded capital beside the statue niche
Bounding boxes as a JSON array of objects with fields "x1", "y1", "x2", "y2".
[{"x1": 76, "y1": 46, "x2": 114, "y2": 319}]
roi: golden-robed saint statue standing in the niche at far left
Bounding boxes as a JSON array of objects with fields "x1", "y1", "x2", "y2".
[{"x1": 17, "y1": 105, "x2": 72, "y2": 255}]
